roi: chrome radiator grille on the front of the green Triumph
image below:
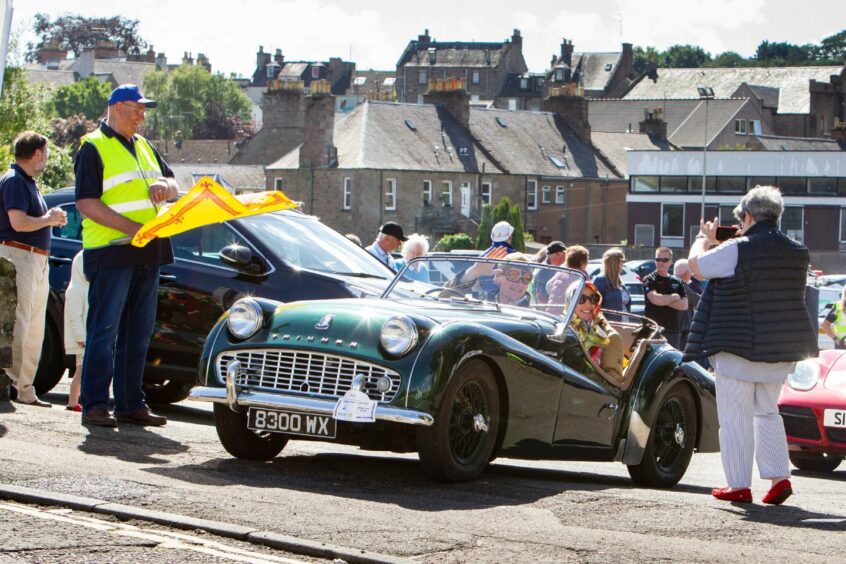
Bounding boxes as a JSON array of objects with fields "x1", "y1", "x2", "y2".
[{"x1": 217, "y1": 349, "x2": 400, "y2": 402}]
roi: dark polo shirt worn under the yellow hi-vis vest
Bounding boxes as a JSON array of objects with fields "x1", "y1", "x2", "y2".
[{"x1": 73, "y1": 122, "x2": 174, "y2": 269}]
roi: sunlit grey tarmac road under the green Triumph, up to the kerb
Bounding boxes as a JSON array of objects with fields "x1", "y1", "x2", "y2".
[{"x1": 0, "y1": 387, "x2": 846, "y2": 563}]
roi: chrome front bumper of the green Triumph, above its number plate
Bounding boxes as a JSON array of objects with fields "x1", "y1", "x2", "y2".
[{"x1": 188, "y1": 363, "x2": 435, "y2": 427}]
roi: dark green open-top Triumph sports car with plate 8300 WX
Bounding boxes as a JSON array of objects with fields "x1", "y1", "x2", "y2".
[{"x1": 190, "y1": 255, "x2": 718, "y2": 487}]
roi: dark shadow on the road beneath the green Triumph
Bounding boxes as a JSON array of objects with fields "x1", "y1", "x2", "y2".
[{"x1": 144, "y1": 453, "x2": 710, "y2": 511}]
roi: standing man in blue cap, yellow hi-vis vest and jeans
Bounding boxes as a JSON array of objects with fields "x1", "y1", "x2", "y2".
[{"x1": 74, "y1": 84, "x2": 178, "y2": 427}]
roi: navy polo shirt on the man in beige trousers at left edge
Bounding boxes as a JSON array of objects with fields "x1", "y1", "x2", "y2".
[{"x1": 0, "y1": 164, "x2": 50, "y2": 251}]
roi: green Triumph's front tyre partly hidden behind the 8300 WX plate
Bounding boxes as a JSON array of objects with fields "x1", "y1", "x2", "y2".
[{"x1": 214, "y1": 403, "x2": 288, "y2": 461}]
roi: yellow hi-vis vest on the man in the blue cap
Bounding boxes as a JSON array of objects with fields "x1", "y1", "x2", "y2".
[{"x1": 82, "y1": 128, "x2": 162, "y2": 249}]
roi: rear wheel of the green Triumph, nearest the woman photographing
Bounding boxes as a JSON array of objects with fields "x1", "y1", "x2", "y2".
[{"x1": 628, "y1": 386, "x2": 697, "y2": 488}]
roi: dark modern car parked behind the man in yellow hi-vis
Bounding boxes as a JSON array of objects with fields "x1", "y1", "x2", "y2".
[{"x1": 35, "y1": 188, "x2": 394, "y2": 403}]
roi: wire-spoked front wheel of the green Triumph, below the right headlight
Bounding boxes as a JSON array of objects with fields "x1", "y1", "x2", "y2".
[{"x1": 417, "y1": 360, "x2": 500, "y2": 482}]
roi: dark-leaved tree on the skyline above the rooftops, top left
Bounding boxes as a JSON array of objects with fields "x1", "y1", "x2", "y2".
[{"x1": 26, "y1": 13, "x2": 147, "y2": 61}]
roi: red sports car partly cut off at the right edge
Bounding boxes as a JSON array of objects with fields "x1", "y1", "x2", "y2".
[{"x1": 778, "y1": 350, "x2": 846, "y2": 472}]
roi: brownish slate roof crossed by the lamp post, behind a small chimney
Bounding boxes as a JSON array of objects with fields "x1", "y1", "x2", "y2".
[{"x1": 588, "y1": 97, "x2": 751, "y2": 147}]
